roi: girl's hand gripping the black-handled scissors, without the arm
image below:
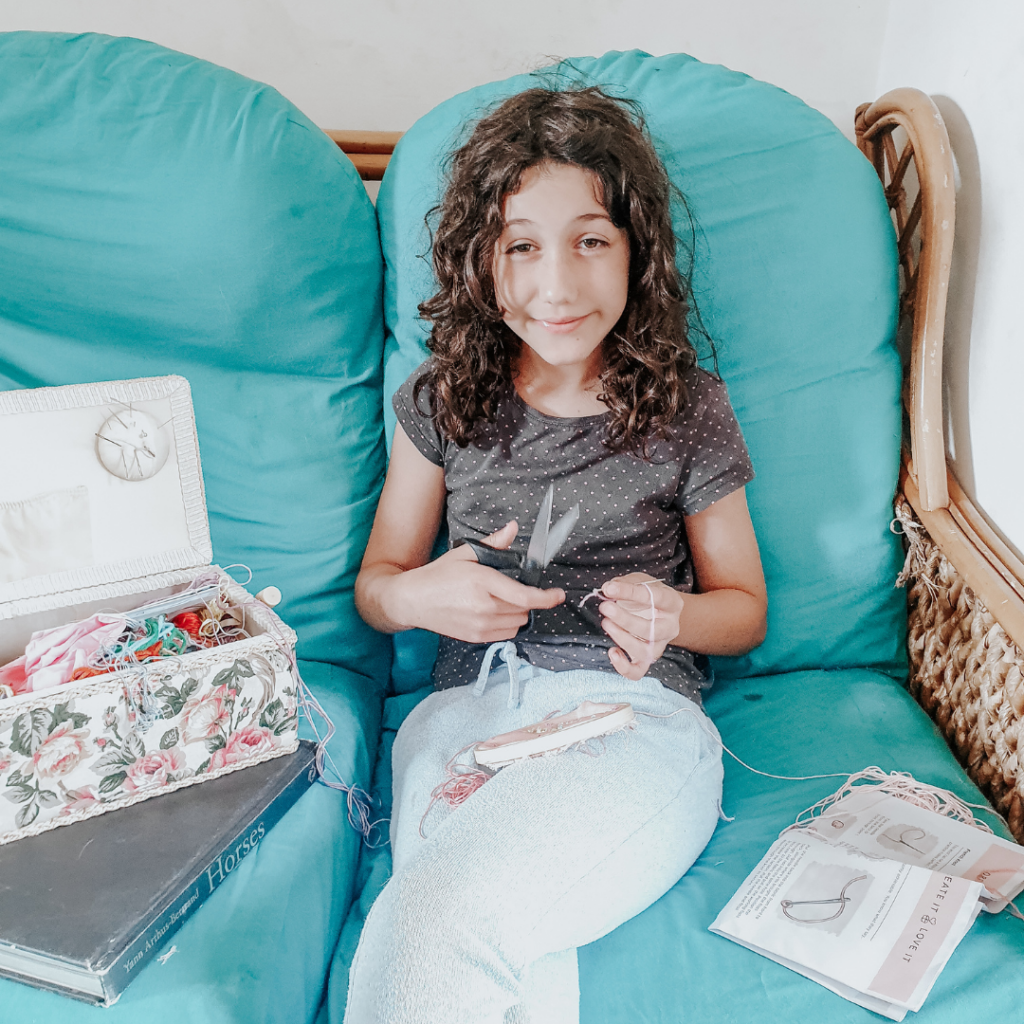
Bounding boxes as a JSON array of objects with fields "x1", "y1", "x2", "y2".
[{"x1": 386, "y1": 520, "x2": 565, "y2": 643}]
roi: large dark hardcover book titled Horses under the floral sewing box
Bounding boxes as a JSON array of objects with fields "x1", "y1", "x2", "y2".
[{"x1": 0, "y1": 740, "x2": 316, "y2": 1006}]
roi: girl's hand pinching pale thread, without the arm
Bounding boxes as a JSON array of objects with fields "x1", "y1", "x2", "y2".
[{"x1": 598, "y1": 572, "x2": 683, "y2": 679}]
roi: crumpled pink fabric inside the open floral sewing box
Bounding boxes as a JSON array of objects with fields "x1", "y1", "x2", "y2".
[{"x1": 0, "y1": 615, "x2": 127, "y2": 693}]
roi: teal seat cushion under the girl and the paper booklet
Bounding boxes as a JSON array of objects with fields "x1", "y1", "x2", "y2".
[{"x1": 322, "y1": 669, "x2": 1024, "y2": 1024}]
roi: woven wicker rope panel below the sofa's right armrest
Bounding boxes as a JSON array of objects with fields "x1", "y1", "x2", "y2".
[{"x1": 895, "y1": 495, "x2": 1024, "y2": 843}]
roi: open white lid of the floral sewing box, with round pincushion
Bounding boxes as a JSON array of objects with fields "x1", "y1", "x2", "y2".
[{"x1": 0, "y1": 377, "x2": 213, "y2": 620}]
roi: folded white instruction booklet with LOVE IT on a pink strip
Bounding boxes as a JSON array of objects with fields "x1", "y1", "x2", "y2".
[{"x1": 710, "y1": 786, "x2": 1024, "y2": 1021}]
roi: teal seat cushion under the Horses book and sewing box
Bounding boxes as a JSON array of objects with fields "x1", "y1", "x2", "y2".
[{"x1": 0, "y1": 662, "x2": 380, "y2": 1024}]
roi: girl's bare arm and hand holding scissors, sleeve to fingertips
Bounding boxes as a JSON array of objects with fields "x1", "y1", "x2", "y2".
[{"x1": 355, "y1": 425, "x2": 565, "y2": 643}]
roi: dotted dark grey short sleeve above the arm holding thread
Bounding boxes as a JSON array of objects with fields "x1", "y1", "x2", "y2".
[{"x1": 675, "y1": 370, "x2": 754, "y2": 515}]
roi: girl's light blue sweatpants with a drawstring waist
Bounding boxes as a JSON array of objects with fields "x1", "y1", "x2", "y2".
[{"x1": 345, "y1": 662, "x2": 722, "y2": 1024}]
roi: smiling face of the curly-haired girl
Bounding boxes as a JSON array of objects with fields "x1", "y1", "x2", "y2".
[{"x1": 495, "y1": 163, "x2": 630, "y2": 376}]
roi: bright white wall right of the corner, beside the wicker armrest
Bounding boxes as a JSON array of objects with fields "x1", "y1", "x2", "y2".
[{"x1": 876, "y1": 0, "x2": 1024, "y2": 552}]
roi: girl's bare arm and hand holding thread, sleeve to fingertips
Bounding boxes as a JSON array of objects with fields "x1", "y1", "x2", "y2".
[{"x1": 600, "y1": 487, "x2": 768, "y2": 679}]
